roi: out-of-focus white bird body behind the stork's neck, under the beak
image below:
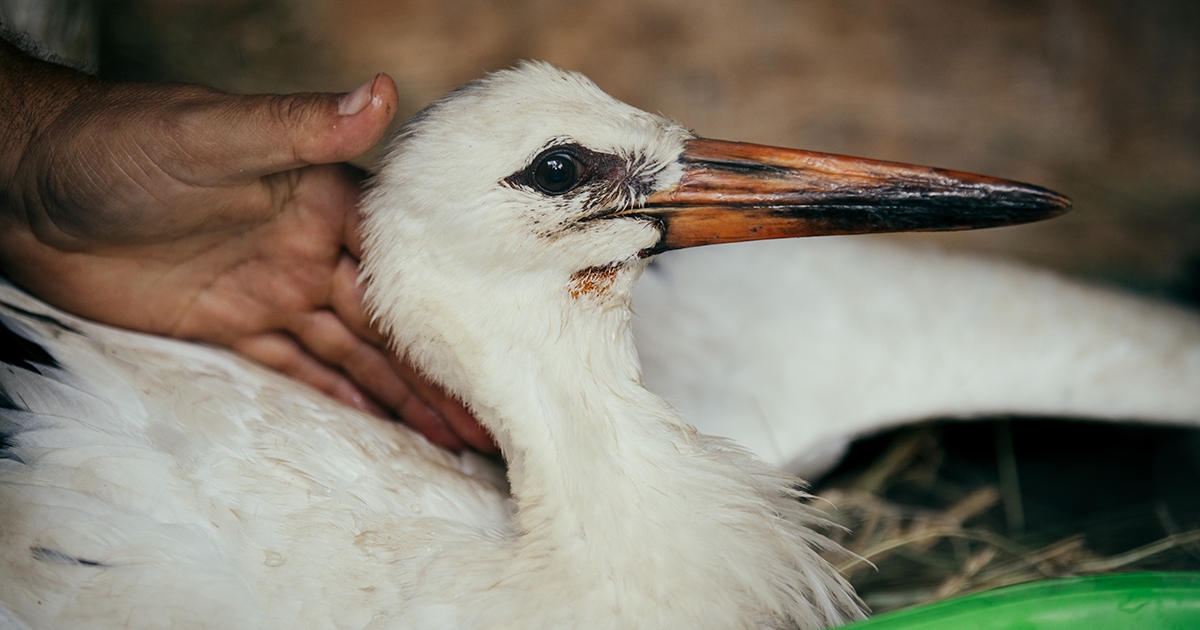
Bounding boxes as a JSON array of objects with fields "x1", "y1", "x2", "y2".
[{"x1": 634, "y1": 236, "x2": 1200, "y2": 479}]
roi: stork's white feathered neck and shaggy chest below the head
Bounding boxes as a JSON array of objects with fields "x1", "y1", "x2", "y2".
[{"x1": 388, "y1": 259, "x2": 856, "y2": 628}]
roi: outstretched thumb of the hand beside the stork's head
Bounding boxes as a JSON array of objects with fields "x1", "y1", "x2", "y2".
[{"x1": 187, "y1": 73, "x2": 398, "y2": 180}]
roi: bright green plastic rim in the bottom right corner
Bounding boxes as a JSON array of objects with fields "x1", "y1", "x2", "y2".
[{"x1": 845, "y1": 572, "x2": 1200, "y2": 630}]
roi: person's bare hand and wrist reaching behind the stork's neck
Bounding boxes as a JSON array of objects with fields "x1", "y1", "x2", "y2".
[{"x1": 0, "y1": 42, "x2": 496, "y2": 452}]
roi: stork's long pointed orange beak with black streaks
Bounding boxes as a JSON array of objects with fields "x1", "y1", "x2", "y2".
[{"x1": 610, "y1": 139, "x2": 1070, "y2": 256}]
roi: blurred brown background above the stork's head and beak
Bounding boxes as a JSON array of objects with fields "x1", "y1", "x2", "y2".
[{"x1": 58, "y1": 0, "x2": 1200, "y2": 302}]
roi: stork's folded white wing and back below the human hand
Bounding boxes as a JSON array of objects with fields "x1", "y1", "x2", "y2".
[{"x1": 0, "y1": 284, "x2": 510, "y2": 628}]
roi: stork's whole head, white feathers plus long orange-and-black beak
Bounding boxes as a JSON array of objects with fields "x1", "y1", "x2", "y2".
[{"x1": 362, "y1": 62, "x2": 1069, "y2": 417}]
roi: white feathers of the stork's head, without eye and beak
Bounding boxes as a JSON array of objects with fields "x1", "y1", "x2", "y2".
[{"x1": 364, "y1": 62, "x2": 691, "y2": 434}]
